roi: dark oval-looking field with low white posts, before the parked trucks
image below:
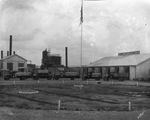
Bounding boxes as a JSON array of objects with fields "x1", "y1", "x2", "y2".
[{"x1": 0, "y1": 79, "x2": 150, "y2": 111}]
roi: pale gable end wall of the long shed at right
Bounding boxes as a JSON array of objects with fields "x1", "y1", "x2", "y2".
[{"x1": 136, "y1": 59, "x2": 150, "y2": 79}]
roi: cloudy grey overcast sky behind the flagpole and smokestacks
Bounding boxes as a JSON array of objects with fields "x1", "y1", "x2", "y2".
[{"x1": 0, "y1": 0, "x2": 150, "y2": 66}]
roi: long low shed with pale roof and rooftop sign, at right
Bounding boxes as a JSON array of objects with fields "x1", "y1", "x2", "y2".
[{"x1": 88, "y1": 51, "x2": 150, "y2": 80}]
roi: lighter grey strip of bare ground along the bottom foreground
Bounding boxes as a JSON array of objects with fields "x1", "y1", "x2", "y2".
[{"x1": 0, "y1": 107, "x2": 150, "y2": 120}]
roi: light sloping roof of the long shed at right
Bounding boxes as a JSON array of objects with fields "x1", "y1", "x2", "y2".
[{"x1": 88, "y1": 53, "x2": 150, "y2": 67}]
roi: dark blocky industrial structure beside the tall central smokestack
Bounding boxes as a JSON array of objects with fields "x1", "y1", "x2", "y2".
[{"x1": 42, "y1": 49, "x2": 61, "y2": 68}]
